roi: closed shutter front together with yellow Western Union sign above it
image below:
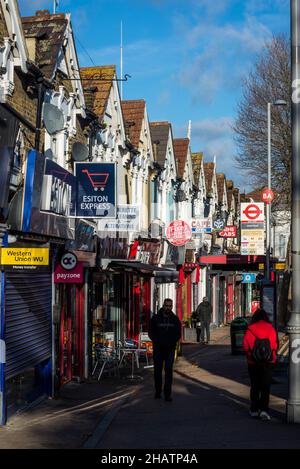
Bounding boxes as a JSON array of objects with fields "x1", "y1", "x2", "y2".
[{"x1": 1, "y1": 247, "x2": 52, "y2": 424}]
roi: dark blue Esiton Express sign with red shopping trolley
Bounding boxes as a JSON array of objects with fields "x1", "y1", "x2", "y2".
[{"x1": 75, "y1": 163, "x2": 117, "y2": 218}]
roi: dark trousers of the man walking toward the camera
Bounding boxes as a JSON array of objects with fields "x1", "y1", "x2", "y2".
[{"x1": 153, "y1": 347, "x2": 175, "y2": 396}]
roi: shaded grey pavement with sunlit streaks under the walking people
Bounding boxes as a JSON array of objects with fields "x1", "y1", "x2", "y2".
[{"x1": 0, "y1": 327, "x2": 300, "y2": 450}]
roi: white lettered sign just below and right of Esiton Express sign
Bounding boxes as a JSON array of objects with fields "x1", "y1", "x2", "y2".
[{"x1": 98, "y1": 205, "x2": 140, "y2": 233}]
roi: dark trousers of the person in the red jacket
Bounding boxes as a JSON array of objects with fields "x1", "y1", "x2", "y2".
[{"x1": 248, "y1": 363, "x2": 274, "y2": 412}]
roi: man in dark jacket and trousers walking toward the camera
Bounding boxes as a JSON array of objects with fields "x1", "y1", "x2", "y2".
[{"x1": 149, "y1": 299, "x2": 181, "y2": 402}]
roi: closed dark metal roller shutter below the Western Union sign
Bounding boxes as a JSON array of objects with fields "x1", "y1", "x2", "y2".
[{"x1": 5, "y1": 272, "x2": 52, "y2": 379}]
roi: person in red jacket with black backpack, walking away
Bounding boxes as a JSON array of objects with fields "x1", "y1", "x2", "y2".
[{"x1": 243, "y1": 309, "x2": 278, "y2": 420}]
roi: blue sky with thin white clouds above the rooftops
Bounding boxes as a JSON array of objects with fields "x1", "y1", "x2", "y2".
[{"x1": 19, "y1": 0, "x2": 290, "y2": 189}]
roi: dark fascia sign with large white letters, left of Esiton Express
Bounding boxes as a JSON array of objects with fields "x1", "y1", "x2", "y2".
[{"x1": 40, "y1": 158, "x2": 76, "y2": 217}]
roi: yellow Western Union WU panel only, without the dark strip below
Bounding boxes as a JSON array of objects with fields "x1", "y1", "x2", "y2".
[{"x1": 1, "y1": 248, "x2": 49, "y2": 265}]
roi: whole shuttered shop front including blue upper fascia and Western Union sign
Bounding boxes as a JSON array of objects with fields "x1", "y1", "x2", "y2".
[{"x1": 1, "y1": 150, "x2": 75, "y2": 423}]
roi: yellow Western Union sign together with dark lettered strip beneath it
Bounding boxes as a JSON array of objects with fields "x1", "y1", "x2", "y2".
[{"x1": 1, "y1": 247, "x2": 49, "y2": 271}]
